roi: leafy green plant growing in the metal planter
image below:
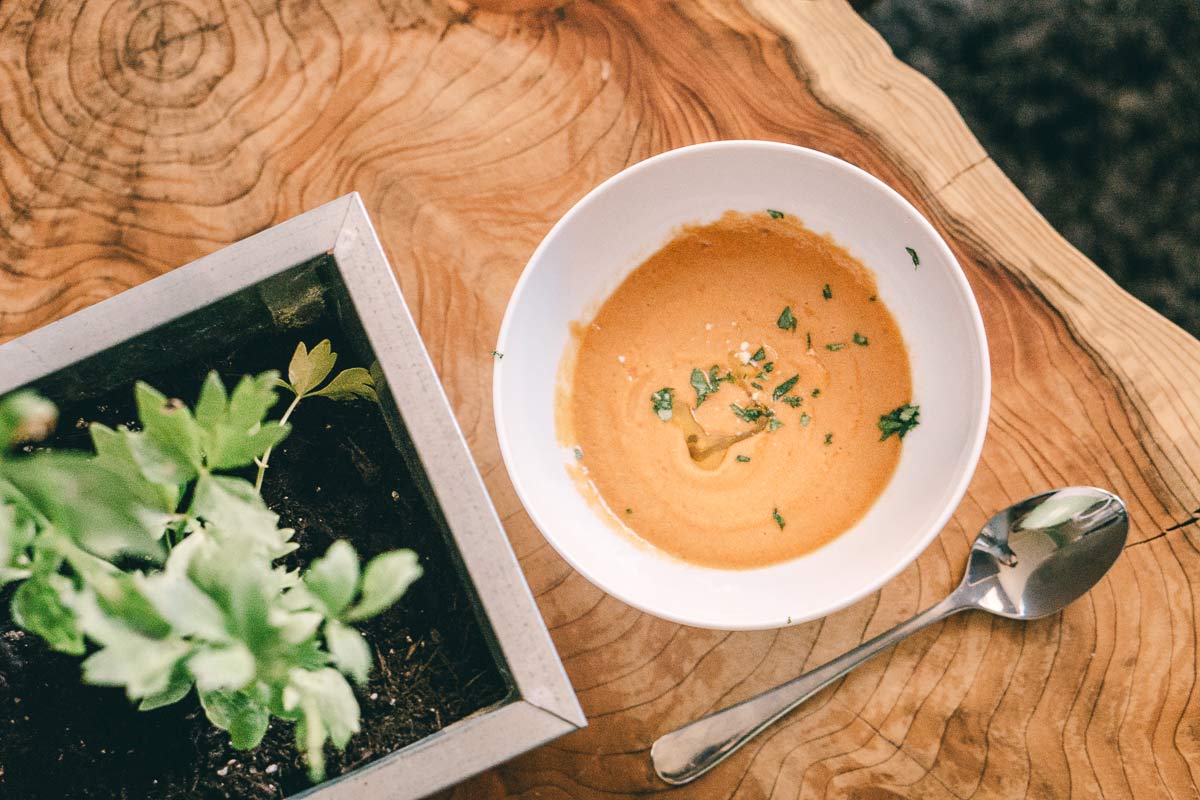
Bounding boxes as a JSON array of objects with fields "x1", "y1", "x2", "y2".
[{"x1": 0, "y1": 341, "x2": 421, "y2": 781}]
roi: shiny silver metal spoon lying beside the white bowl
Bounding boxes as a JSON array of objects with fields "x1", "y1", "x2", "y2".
[{"x1": 650, "y1": 487, "x2": 1129, "y2": 786}]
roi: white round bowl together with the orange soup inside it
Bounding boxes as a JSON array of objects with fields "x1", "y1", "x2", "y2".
[{"x1": 494, "y1": 142, "x2": 989, "y2": 630}]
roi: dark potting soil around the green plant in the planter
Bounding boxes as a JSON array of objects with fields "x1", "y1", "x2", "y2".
[{"x1": 0, "y1": 323, "x2": 508, "y2": 800}]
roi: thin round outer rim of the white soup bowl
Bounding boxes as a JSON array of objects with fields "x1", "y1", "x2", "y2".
[{"x1": 492, "y1": 139, "x2": 991, "y2": 631}]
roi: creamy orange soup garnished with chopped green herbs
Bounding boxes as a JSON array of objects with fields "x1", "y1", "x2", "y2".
[{"x1": 557, "y1": 211, "x2": 918, "y2": 569}]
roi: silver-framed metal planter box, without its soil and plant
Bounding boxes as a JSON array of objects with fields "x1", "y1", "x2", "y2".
[{"x1": 0, "y1": 194, "x2": 587, "y2": 800}]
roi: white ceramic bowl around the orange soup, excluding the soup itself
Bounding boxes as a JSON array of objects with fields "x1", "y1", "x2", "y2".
[{"x1": 494, "y1": 142, "x2": 991, "y2": 630}]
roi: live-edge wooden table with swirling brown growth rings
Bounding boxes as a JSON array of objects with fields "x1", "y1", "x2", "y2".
[{"x1": 0, "y1": 0, "x2": 1200, "y2": 800}]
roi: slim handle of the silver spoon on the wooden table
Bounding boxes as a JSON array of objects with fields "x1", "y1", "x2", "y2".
[{"x1": 650, "y1": 595, "x2": 967, "y2": 786}]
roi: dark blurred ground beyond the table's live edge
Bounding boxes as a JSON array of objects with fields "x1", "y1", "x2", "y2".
[{"x1": 858, "y1": 0, "x2": 1200, "y2": 335}]
